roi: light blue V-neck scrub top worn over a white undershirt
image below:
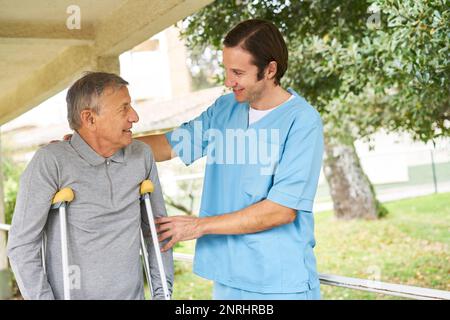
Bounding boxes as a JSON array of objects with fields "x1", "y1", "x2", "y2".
[{"x1": 166, "y1": 89, "x2": 323, "y2": 293}]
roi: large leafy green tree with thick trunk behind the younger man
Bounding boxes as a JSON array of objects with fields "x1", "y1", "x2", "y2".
[{"x1": 182, "y1": 0, "x2": 449, "y2": 219}]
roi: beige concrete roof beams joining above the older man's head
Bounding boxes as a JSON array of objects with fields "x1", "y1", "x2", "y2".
[{"x1": 0, "y1": 0, "x2": 212, "y2": 125}]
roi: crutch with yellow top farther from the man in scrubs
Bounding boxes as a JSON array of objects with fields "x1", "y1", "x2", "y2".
[{"x1": 42, "y1": 188, "x2": 74, "y2": 300}]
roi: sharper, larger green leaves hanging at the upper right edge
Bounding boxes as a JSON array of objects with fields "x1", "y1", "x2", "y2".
[{"x1": 359, "y1": 0, "x2": 450, "y2": 141}]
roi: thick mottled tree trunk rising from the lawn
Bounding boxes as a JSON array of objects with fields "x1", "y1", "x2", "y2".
[{"x1": 324, "y1": 137, "x2": 379, "y2": 220}]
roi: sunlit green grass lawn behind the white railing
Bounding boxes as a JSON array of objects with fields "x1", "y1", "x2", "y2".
[{"x1": 173, "y1": 193, "x2": 450, "y2": 299}]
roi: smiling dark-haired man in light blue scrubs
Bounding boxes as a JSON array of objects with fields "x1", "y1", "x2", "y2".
[{"x1": 140, "y1": 19, "x2": 323, "y2": 300}]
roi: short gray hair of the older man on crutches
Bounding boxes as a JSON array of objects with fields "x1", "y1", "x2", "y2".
[{"x1": 66, "y1": 72, "x2": 128, "y2": 130}]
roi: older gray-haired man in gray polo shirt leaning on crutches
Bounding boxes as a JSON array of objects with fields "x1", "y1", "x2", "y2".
[{"x1": 8, "y1": 72, "x2": 173, "y2": 299}]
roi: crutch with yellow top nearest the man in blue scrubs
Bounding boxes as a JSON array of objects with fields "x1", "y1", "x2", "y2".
[{"x1": 140, "y1": 180, "x2": 170, "y2": 300}]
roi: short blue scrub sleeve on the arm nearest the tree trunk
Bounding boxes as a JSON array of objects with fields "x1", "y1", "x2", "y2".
[{"x1": 267, "y1": 118, "x2": 324, "y2": 212}]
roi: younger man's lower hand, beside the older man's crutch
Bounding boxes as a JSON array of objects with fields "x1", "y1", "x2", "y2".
[{"x1": 155, "y1": 216, "x2": 202, "y2": 252}]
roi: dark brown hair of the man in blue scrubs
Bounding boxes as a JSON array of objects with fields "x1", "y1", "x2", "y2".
[{"x1": 223, "y1": 19, "x2": 288, "y2": 85}]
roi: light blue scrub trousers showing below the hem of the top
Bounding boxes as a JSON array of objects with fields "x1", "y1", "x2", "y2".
[{"x1": 213, "y1": 282, "x2": 321, "y2": 300}]
